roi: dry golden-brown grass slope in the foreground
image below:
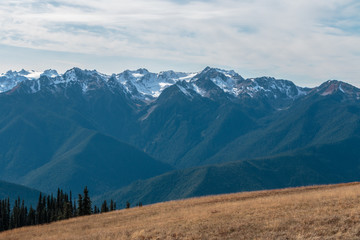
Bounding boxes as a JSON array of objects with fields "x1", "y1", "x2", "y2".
[{"x1": 0, "y1": 183, "x2": 360, "y2": 240}]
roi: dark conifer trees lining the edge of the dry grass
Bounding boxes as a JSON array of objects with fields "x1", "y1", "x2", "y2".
[{"x1": 0, "y1": 187, "x2": 116, "y2": 232}]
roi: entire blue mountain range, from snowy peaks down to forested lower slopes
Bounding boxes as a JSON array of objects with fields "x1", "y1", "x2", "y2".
[{"x1": 0, "y1": 67, "x2": 360, "y2": 202}]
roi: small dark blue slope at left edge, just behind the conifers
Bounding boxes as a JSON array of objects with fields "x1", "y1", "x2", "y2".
[{"x1": 0, "y1": 181, "x2": 40, "y2": 207}]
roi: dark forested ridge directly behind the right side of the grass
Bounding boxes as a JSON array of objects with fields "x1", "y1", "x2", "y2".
[{"x1": 99, "y1": 138, "x2": 360, "y2": 204}]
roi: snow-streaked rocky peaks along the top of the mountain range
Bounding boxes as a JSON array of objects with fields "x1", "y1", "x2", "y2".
[{"x1": 0, "y1": 67, "x2": 360, "y2": 105}]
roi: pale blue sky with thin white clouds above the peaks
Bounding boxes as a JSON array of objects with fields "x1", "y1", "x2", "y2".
[{"x1": 0, "y1": 0, "x2": 360, "y2": 87}]
